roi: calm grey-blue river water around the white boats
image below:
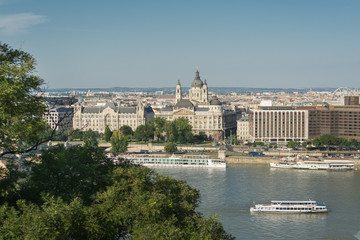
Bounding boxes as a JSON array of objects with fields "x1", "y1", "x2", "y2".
[{"x1": 156, "y1": 165, "x2": 360, "y2": 239}]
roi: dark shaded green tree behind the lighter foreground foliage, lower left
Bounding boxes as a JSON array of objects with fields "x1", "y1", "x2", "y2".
[{"x1": 20, "y1": 145, "x2": 114, "y2": 206}]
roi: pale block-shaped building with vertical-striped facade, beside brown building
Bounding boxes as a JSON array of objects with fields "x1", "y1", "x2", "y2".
[{"x1": 249, "y1": 107, "x2": 309, "y2": 142}]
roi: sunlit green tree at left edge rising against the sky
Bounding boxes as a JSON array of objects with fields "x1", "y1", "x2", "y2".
[{"x1": 0, "y1": 42, "x2": 47, "y2": 156}]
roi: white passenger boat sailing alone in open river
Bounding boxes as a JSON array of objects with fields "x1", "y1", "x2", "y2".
[{"x1": 250, "y1": 200, "x2": 328, "y2": 213}]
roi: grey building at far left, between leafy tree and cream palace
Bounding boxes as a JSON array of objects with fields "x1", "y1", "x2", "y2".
[{"x1": 44, "y1": 107, "x2": 74, "y2": 132}]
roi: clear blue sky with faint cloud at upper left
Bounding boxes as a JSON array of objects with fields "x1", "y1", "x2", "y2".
[{"x1": 0, "y1": 0, "x2": 360, "y2": 88}]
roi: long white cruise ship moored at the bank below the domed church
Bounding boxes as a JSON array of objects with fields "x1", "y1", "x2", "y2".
[{"x1": 118, "y1": 154, "x2": 226, "y2": 168}]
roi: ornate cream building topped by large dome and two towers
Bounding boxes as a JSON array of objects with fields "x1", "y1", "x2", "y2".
[{"x1": 155, "y1": 70, "x2": 237, "y2": 140}]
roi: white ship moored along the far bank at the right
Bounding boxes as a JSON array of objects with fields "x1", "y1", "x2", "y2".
[{"x1": 270, "y1": 159, "x2": 355, "y2": 170}]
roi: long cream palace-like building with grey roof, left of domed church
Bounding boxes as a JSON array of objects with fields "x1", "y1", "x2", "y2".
[{"x1": 73, "y1": 102, "x2": 154, "y2": 133}]
